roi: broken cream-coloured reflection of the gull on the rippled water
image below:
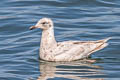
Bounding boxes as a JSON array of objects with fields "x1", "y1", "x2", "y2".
[{"x1": 37, "y1": 61, "x2": 104, "y2": 80}]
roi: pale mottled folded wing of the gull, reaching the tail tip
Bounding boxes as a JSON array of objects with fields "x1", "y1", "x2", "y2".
[{"x1": 55, "y1": 38, "x2": 110, "y2": 61}]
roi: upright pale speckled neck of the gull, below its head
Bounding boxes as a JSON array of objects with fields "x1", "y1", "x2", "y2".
[{"x1": 41, "y1": 27, "x2": 57, "y2": 48}]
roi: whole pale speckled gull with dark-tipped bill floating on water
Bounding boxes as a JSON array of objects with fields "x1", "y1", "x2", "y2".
[{"x1": 30, "y1": 18, "x2": 110, "y2": 61}]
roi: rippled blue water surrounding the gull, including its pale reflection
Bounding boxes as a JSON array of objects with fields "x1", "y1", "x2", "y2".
[{"x1": 0, "y1": 0, "x2": 120, "y2": 80}]
